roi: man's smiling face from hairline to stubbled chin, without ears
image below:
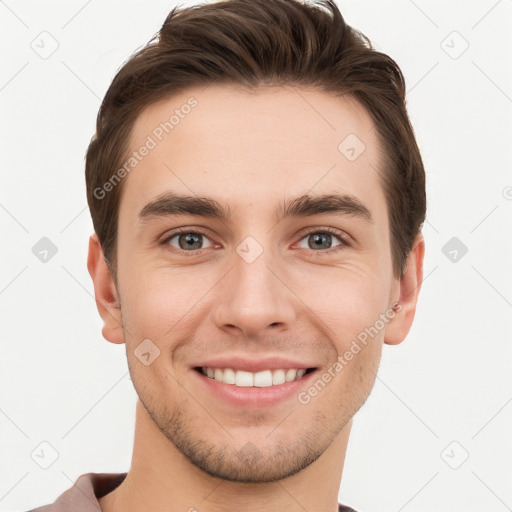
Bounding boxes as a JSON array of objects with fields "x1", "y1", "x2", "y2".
[{"x1": 103, "y1": 87, "x2": 408, "y2": 482}]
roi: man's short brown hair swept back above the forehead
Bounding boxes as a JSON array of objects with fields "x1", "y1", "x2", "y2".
[{"x1": 85, "y1": 0, "x2": 426, "y2": 279}]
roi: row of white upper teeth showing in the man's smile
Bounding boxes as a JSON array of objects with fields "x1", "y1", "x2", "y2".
[{"x1": 201, "y1": 366, "x2": 306, "y2": 388}]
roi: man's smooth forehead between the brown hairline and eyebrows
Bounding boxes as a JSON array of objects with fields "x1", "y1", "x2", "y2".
[{"x1": 120, "y1": 86, "x2": 385, "y2": 221}]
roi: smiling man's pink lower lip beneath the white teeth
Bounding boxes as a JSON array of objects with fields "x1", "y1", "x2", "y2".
[{"x1": 192, "y1": 370, "x2": 317, "y2": 408}]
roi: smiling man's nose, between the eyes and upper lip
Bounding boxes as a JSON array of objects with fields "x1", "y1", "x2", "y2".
[{"x1": 213, "y1": 247, "x2": 298, "y2": 337}]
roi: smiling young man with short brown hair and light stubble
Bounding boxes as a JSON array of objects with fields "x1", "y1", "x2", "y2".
[{"x1": 30, "y1": 0, "x2": 426, "y2": 512}]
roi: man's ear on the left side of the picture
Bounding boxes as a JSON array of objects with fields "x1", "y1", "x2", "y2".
[{"x1": 87, "y1": 233, "x2": 124, "y2": 343}]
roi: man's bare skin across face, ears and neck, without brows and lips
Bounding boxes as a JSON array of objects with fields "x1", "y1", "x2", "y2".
[{"x1": 88, "y1": 86, "x2": 424, "y2": 512}]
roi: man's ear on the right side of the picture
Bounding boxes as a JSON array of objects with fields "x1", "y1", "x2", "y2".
[{"x1": 384, "y1": 233, "x2": 425, "y2": 345}]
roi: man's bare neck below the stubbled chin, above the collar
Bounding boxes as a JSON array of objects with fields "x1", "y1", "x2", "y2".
[{"x1": 98, "y1": 400, "x2": 352, "y2": 512}]
